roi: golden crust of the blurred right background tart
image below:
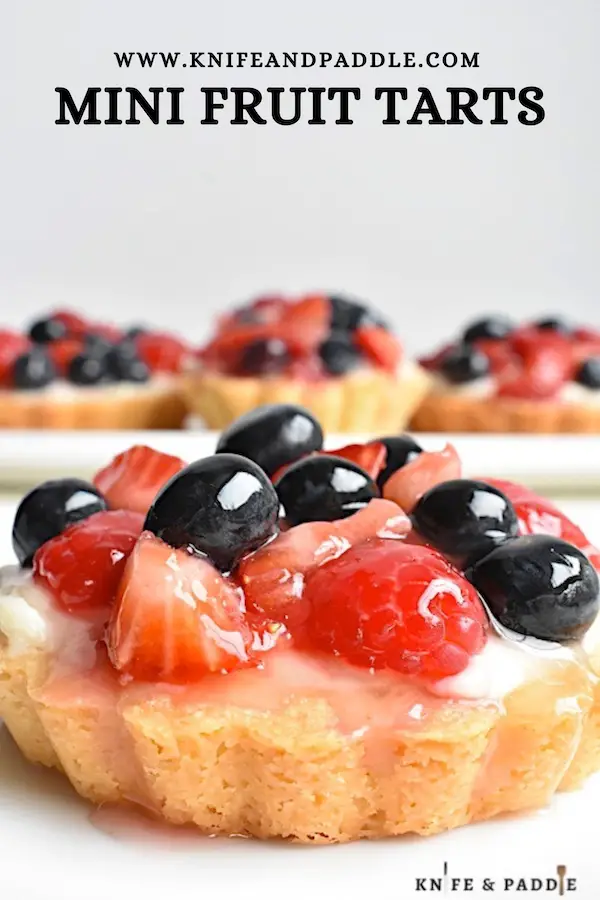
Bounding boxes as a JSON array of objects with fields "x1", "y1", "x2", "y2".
[{"x1": 410, "y1": 391, "x2": 600, "y2": 434}]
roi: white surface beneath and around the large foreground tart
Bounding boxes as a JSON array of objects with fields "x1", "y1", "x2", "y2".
[{"x1": 0, "y1": 499, "x2": 600, "y2": 900}]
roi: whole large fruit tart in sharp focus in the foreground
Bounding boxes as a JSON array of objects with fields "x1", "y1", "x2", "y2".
[{"x1": 0, "y1": 406, "x2": 600, "y2": 843}]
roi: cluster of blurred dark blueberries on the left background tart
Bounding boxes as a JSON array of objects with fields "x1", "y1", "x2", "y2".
[{"x1": 12, "y1": 317, "x2": 150, "y2": 390}]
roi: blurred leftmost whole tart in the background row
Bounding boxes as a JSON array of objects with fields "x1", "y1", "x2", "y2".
[{"x1": 0, "y1": 310, "x2": 191, "y2": 430}]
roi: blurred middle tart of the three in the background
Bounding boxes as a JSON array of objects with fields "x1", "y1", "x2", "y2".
[{"x1": 188, "y1": 295, "x2": 429, "y2": 434}]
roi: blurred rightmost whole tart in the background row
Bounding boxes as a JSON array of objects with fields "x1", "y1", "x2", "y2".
[{"x1": 411, "y1": 316, "x2": 600, "y2": 433}]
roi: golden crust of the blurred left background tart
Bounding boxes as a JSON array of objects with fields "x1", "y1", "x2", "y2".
[{"x1": 0, "y1": 379, "x2": 187, "y2": 431}]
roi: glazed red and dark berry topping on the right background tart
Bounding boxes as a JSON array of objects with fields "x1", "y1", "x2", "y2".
[{"x1": 420, "y1": 316, "x2": 600, "y2": 400}]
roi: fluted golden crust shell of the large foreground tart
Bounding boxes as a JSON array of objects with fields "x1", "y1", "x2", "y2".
[{"x1": 0, "y1": 638, "x2": 600, "y2": 843}]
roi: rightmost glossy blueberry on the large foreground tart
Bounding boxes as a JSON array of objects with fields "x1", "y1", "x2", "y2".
[{"x1": 465, "y1": 534, "x2": 600, "y2": 643}]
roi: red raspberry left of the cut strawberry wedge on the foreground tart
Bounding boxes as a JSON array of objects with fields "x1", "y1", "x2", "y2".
[{"x1": 33, "y1": 510, "x2": 144, "y2": 613}]
